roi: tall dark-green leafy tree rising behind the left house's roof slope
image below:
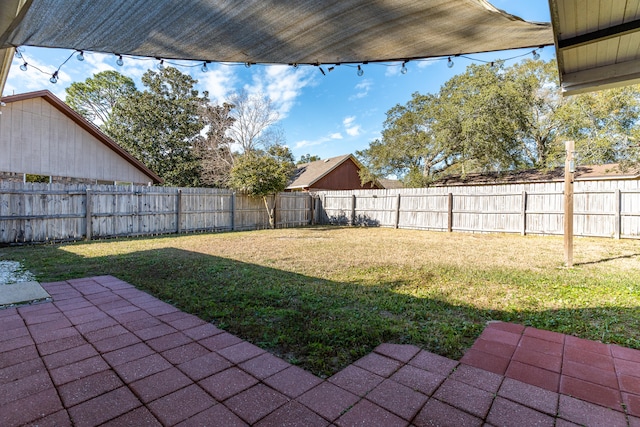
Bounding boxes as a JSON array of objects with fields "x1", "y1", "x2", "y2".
[{"x1": 105, "y1": 67, "x2": 208, "y2": 187}]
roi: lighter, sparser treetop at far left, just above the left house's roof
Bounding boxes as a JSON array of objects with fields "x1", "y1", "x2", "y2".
[{"x1": 65, "y1": 71, "x2": 137, "y2": 126}]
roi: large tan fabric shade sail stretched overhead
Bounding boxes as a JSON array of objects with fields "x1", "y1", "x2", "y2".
[{"x1": 0, "y1": 0, "x2": 553, "y2": 93}]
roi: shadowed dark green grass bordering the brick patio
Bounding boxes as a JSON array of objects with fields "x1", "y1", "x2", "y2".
[{"x1": 5, "y1": 246, "x2": 640, "y2": 376}]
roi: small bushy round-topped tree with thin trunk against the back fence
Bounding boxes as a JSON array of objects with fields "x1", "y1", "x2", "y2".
[{"x1": 229, "y1": 145, "x2": 295, "y2": 228}]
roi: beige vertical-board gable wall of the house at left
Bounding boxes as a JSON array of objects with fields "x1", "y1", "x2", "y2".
[{"x1": 0, "y1": 97, "x2": 151, "y2": 184}]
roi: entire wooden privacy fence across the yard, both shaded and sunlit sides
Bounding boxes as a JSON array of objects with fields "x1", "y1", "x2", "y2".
[{"x1": 0, "y1": 181, "x2": 640, "y2": 243}]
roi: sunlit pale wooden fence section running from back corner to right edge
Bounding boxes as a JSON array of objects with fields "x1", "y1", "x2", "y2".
[{"x1": 316, "y1": 181, "x2": 640, "y2": 238}]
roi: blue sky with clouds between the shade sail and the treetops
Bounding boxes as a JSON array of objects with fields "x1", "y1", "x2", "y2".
[{"x1": 3, "y1": 0, "x2": 555, "y2": 163}]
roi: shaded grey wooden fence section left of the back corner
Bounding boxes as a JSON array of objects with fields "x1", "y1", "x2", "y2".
[{"x1": 0, "y1": 182, "x2": 313, "y2": 243}]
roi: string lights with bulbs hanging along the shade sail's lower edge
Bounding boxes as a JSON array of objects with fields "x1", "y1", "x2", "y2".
[{"x1": 15, "y1": 46, "x2": 544, "y2": 84}]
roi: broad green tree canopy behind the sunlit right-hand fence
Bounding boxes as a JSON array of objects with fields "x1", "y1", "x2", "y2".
[{"x1": 357, "y1": 60, "x2": 640, "y2": 187}]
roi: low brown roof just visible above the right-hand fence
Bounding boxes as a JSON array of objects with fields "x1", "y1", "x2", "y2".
[{"x1": 432, "y1": 163, "x2": 640, "y2": 186}]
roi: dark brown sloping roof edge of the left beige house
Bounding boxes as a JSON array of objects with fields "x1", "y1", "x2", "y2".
[{"x1": 2, "y1": 90, "x2": 163, "y2": 184}]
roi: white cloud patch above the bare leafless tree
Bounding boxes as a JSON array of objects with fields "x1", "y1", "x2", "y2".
[{"x1": 245, "y1": 65, "x2": 314, "y2": 119}]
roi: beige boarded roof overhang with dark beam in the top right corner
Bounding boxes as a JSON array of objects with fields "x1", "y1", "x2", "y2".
[{"x1": 549, "y1": 0, "x2": 640, "y2": 95}]
